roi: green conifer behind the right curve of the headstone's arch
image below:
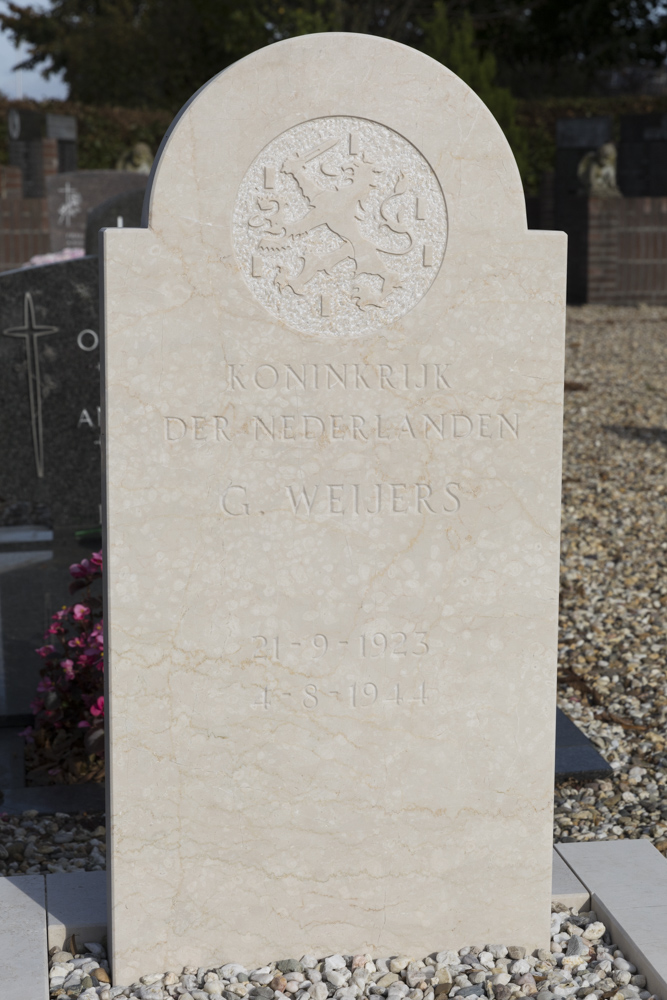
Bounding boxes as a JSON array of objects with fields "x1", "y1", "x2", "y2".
[{"x1": 422, "y1": 0, "x2": 527, "y2": 176}]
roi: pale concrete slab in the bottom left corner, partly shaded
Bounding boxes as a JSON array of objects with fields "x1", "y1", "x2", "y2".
[{"x1": 0, "y1": 875, "x2": 49, "y2": 1000}]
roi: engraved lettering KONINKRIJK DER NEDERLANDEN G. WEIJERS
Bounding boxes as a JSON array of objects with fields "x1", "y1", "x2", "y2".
[{"x1": 162, "y1": 362, "x2": 519, "y2": 517}]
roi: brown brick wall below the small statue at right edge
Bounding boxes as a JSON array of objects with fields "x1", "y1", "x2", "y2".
[{"x1": 587, "y1": 198, "x2": 667, "y2": 305}]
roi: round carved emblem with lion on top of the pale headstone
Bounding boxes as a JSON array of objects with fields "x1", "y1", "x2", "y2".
[{"x1": 234, "y1": 117, "x2": 447, "y2": 336}]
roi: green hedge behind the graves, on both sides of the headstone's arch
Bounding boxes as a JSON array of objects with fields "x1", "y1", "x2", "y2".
[{"x1": 0, "y1": 95, "x2": 667, "y2": 194}]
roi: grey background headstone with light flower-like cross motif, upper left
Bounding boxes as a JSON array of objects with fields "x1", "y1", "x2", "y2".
[{"x1": 46, "y1": 170, "x2": 147, "y2": 251}]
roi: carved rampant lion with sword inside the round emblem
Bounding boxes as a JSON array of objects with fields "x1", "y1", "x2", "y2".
[{"x1": 249, "y1": 139, "x2": 414, "y2": 309}]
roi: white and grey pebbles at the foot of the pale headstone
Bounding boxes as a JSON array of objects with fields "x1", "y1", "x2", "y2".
[{"x1": 50, "y1": 908, "x2": 664, "y2": 1000}]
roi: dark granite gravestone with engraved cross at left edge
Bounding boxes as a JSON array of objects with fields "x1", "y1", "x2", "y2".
[{"x1": 0, "y1": 257, "x2": 101, "y2": 723}]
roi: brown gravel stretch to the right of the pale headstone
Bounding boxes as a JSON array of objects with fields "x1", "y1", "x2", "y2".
[{"x1": 554, "y1": 306, "x2": 667, "y2": 853}]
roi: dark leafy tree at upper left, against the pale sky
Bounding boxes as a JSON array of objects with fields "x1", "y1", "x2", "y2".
[{"x1": 0, "y1": 0, "x2": 271, "y2": 109}]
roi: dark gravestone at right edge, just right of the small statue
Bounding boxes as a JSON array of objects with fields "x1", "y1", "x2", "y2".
[{"x1": 618, "y1": 114, "x2": 667, "y2": 198}]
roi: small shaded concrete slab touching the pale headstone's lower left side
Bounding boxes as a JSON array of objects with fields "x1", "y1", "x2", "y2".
[{"x1": 46, "y1": 872, "x2": 107, "y2": 948}]
